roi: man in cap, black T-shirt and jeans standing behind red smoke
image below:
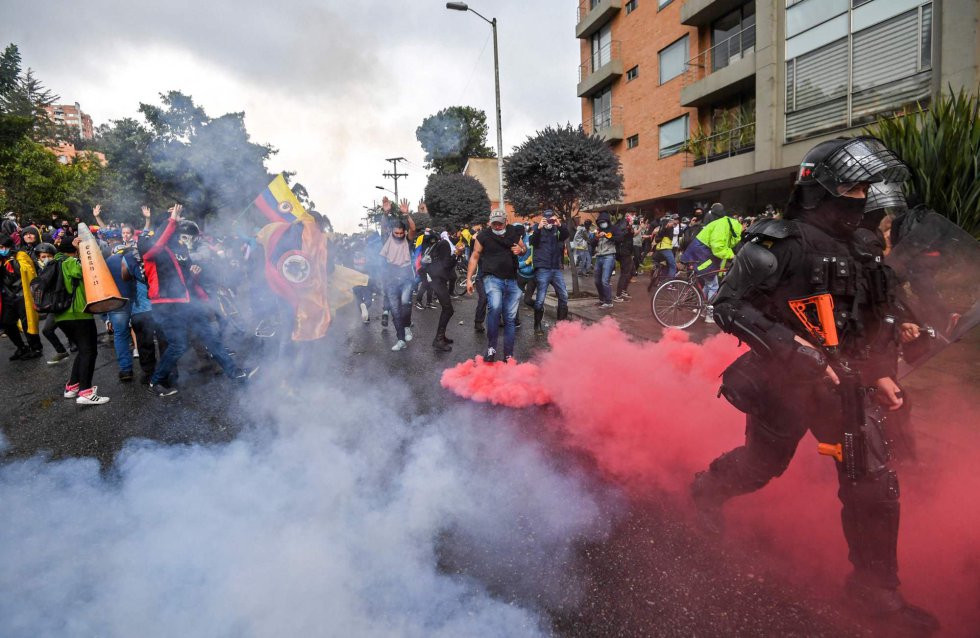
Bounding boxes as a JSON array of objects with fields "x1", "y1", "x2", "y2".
[{"x1": 466, "y1": 210, "x2": 526, "y2": 363}]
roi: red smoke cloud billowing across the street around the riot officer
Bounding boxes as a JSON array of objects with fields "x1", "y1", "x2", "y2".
[{"x1": 442, "y1": 319, "x2": 980, "y2": 636}]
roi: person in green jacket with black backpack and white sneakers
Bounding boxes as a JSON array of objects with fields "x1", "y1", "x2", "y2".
[{"x1": 54, "y1": 236, "x2": 109, "y2": 405}]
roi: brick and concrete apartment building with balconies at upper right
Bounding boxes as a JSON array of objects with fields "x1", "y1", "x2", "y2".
[{"x1": 576, "y1": 0, "x2": 980, "y2": 214}]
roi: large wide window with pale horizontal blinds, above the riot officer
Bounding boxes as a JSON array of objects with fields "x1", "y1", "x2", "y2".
[{"x1": 785, "y1": 0, "x2": 932, "y2": 142}]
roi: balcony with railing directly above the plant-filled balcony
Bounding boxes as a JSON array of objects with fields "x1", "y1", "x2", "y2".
[{"x1": 681, "y1": 25, "x2": 755, "y2": 106}]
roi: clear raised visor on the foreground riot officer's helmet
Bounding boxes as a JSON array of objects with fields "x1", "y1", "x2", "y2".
[{"x1": 813, "y1": 136, "x2": 909, "y2": 196}]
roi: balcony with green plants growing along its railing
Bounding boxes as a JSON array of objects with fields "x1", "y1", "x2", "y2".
[{"x1": 681, "y1": 122, "x2": 755, "y2": 188}]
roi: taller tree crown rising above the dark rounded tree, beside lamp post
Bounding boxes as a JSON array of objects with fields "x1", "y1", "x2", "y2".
[{"x1": 415, "y1": 106, "x2": 497, "y2": 175}]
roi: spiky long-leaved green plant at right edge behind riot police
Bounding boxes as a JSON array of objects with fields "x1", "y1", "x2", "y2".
[{"x1": 868, "y1": 89, "x2": 980, "y2": 237}]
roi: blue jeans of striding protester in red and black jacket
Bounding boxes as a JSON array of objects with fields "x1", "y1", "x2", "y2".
[{"x1": 150, "y1": 302, "x2": 238, "y2": 383}]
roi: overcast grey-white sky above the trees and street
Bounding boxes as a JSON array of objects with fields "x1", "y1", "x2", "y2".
[{"x1": 0, "y1": 0, "x2": 581, "y2": 232}]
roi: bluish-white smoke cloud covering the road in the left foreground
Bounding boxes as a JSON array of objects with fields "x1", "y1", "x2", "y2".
[{"x1": 0, "y1": 379, "x2": 616, "y2": 637}]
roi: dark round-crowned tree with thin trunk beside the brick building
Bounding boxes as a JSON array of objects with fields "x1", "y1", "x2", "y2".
[{"x1": 504, "y1": 124, "x2": 623, "y2": 295}]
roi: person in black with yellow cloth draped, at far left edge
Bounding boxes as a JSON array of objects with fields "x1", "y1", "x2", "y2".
[{"x1": 0, "y1": 235, "x2": 43, "y2": 361}]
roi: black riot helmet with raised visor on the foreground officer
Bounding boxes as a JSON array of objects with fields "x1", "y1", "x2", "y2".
[{"x1": 786, "y1": 135, "x2": 909, "y2": 219}]
